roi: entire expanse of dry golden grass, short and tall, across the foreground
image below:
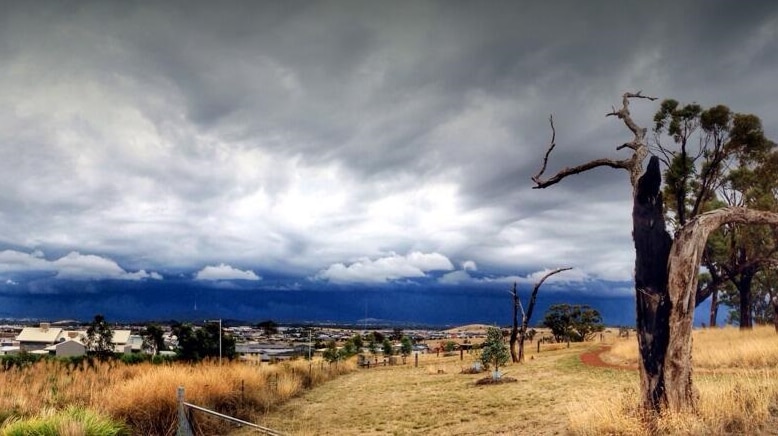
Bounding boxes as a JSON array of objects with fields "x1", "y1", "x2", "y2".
[{"x1": 0, "y1": 328, "x2": 778, "y2": 436}]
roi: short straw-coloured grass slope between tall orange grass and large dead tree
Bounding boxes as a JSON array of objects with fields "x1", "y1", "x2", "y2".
[{"x1": 252, "y1": 344, "x2": 636, "y2": 435}]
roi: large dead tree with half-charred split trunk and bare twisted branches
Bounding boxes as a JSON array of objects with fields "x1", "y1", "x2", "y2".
[{"x1": 532, "y1": 92, "x2": 778, "y2": 416}]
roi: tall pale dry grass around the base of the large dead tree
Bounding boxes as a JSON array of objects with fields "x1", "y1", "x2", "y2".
[{"x1": 568, "y1": 327, "x2": 778, "y2": 435}]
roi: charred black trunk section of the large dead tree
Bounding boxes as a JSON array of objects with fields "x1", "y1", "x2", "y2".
[{"x1": 632, "y1": 156, "x2": 672, "y2": 413}]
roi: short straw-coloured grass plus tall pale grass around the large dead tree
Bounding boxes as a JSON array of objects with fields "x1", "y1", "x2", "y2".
[{"x1": 249, "y1": 328, "x2": 778, "y2": 435}]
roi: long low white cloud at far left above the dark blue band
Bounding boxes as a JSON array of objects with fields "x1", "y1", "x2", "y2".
[{"x1": 0, "y1": 250, "x2": 162, "y2": 280}]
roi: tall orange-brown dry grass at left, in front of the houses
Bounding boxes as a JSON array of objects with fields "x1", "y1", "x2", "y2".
[{"x1": 0, "y1": 361, "x2": 355, "y2": 435}]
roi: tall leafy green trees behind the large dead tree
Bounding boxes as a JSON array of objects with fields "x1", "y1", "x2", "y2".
[{"x1": 654, "y1": 100, "x2": 778, "y2": 328}]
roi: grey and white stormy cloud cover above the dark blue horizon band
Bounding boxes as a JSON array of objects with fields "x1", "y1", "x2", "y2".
[{"x1": 0, "y1": 1, "x2": 778, "y2": 314}]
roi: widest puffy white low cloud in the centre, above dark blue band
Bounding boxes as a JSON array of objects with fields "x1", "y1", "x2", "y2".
[{"x1": 316, "y1": 251, "x2": 454, "y2": 283}]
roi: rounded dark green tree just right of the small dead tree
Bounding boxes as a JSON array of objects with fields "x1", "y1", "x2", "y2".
[{"x1": 543, "y1": 304, "x2": 605, "y2": 342}]
